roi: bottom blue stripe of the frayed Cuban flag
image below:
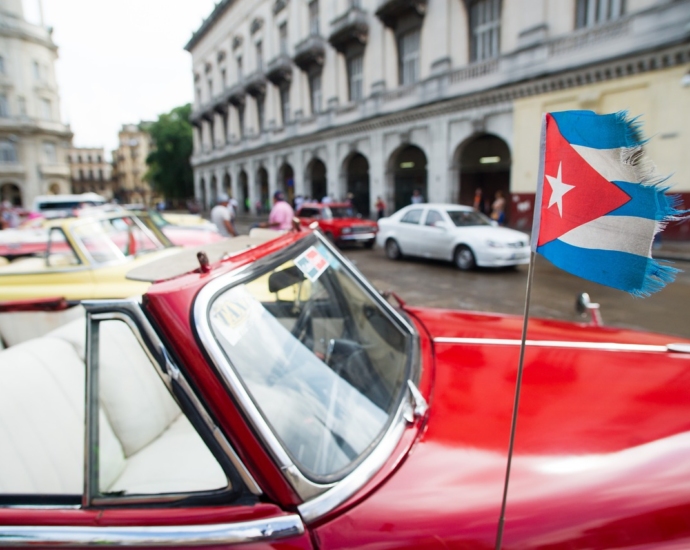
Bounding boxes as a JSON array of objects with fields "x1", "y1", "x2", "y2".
[{"x1": 537, "y1": 239, "x2": 679, "y2": 297}]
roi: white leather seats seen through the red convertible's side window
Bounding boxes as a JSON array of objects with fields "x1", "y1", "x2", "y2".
[{"x1": 0, "y1": 318, "x2": 228, "y2": 500}]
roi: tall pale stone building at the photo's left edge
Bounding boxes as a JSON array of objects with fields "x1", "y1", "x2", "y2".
[{"x1": 0, "y1": 0, "x2": 72, "y2": 208}]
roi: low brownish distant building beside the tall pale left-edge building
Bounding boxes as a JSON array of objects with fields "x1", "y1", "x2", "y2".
[{"x1": 68, "y1": 147, "x2": 116, "y2": 199}]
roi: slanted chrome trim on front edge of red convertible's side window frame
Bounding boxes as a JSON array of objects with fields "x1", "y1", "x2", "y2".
[{"x1": 82, "y1": 299, "x2": 263, "y2": 502}]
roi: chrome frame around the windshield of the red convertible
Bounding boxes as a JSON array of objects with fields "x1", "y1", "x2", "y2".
[{"x1": 192, "y1": 232, "x2": 421, "y2": 521}]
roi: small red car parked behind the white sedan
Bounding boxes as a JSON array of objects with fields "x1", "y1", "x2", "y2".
[{"x1": 297, "y1": 202, "x2": 378, "y2": 248}]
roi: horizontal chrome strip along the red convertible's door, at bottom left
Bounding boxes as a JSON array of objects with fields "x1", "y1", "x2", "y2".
[{"x1": 0, "y1": 514, "x2": 304, "y2": 548}]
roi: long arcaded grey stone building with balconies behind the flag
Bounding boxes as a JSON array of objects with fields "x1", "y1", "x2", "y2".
[{"x1": 186, "y1": 0, "x2": 690, "y2": 235}]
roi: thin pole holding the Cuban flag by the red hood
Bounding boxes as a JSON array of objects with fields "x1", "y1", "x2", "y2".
[{"x1": 495, "y1": 115, "x2": 546, "y2": 550}]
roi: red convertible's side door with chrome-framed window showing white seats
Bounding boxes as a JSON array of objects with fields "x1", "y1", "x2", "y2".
[{"x1": 0, "y1": 302, "x2": 312, "y2": 549}]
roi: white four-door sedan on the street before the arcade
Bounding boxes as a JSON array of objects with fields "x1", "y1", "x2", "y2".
[{"x1": 376, "y1": 204, "x2": 530, "y2": 270}]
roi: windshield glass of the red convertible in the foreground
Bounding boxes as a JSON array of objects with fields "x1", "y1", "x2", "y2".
[{"x1": 204, "y1": 240, "x2": 412, "y2": 481}]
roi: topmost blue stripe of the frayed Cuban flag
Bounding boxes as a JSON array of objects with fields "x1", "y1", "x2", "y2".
[{"x1": 550, "y1": 111, "x2": 644, "y2": 149}]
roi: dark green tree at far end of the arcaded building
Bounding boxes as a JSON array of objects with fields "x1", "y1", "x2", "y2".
[{"x1": 144, "y1": 103, "x2": 194, "y2": 199}]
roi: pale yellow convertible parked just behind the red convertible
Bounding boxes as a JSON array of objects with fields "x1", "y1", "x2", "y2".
[{"x1": 0, "y1": 212, "x2": 178, "y2": 300}]
